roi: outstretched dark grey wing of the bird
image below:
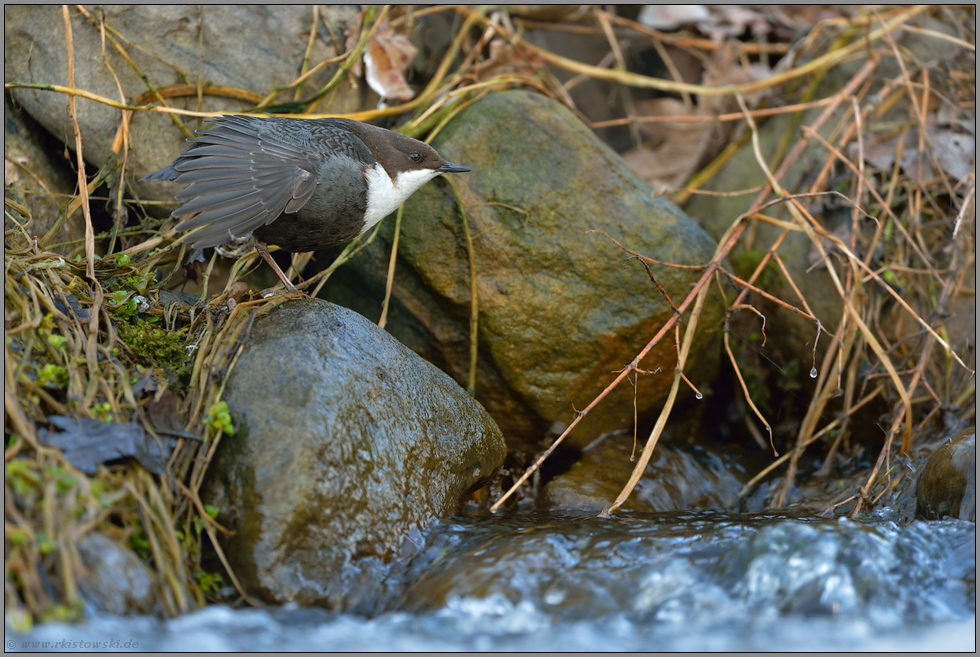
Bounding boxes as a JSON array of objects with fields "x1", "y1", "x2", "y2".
[{"x1": 144, "y1": 116, "x2": 321, "y2": 248}]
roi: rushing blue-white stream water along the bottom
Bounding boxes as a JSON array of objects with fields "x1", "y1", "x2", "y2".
[{"x1": 5, "y1": 512, "x2": 976, "y2": 652}]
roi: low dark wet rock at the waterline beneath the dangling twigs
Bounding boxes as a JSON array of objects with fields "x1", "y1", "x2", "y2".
[{"x1": 542, "y1": 435, "x2": 744, "y2": 513}]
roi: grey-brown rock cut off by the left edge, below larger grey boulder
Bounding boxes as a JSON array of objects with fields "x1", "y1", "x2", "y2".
[{"x1": 3, "y1": 92, "x2": 85, "y2": 243}]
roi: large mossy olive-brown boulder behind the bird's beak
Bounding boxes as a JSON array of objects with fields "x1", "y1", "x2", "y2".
[{"x1": 338, "y1": 91, "x2": 721, "y2": 449}]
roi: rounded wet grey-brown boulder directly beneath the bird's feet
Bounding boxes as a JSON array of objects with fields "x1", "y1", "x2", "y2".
[{"x1": 204, "y1": 299, "x2": 505, "y2": 613}]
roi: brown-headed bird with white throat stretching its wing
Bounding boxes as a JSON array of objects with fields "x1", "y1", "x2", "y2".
[{"x1": 143, "y1": 115, "x2": 470, "y2": 290}]
